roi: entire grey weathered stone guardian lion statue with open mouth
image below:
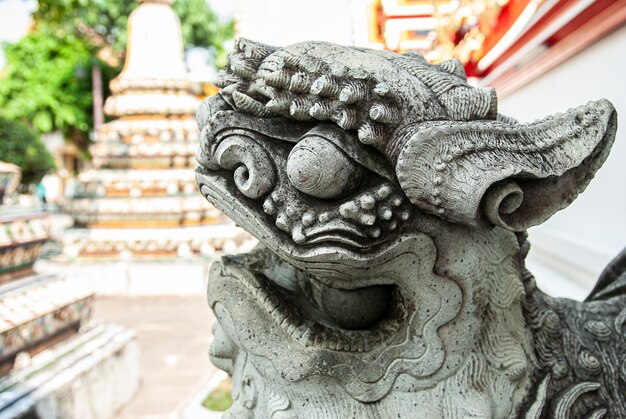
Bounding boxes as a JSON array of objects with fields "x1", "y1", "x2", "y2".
[{"x1": 197, "y1": 39, "x2": 626, "y2": 418}]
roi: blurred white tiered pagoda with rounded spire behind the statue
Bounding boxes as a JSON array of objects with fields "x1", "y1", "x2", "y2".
[{"x1": 65, "y1": 0, "x2": 249, "y2": 258}]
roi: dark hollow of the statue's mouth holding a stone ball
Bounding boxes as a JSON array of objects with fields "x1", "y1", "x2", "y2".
[{"x1": 209, "y1": 248, "x2": 409, "y2": 358}]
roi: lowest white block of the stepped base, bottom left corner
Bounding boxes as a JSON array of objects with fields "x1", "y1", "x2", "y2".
[{"x1": 0, "y1": 324, "x2": 139, "y2": 419}]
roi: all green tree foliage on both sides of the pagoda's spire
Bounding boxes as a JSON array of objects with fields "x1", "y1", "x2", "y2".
[{"x1": 0, "y1": 0, "x2": 233, "y2": 149}]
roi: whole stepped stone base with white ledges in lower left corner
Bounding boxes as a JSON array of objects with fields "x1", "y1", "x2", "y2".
[{"x1": 0, "y1": 207, "x2": 139, "y2": 419}]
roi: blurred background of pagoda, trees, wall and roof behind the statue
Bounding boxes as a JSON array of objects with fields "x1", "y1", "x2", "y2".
[{"x1": 0, "y1": 0, "x2": 626, "y2": 419}]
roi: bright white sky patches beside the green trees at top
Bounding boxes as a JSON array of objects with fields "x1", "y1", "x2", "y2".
[{"x1": 0, "y1": 0, "x2": 236, "y2": 68}]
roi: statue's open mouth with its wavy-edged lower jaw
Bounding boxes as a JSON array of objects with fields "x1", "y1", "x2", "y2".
[{"x1": 198, "y1": 213, "x2": 470, "y2": 402}]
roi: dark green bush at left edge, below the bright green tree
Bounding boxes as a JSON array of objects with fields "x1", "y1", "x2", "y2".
[{"x1": 0, "y1": 117, "x2": 54, "y2": 184}]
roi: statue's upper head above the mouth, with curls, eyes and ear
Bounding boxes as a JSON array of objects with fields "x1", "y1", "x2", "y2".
[{"x1": 198, "y1": 39, "x2": 616, "y2": 270}]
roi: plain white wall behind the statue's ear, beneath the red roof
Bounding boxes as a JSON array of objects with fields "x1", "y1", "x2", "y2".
[{"x1": 500, "y1": 26, "x2": 626, "y2": 298}]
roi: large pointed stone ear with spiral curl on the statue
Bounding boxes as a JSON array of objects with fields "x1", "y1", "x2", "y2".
[{"x1": 389, "y1": 100, "x2": 617, "y2": 231}]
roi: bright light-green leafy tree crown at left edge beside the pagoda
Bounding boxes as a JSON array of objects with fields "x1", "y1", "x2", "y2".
[{"x1": 0, "y1": 32, "x2": 92, "y2": 151}]
